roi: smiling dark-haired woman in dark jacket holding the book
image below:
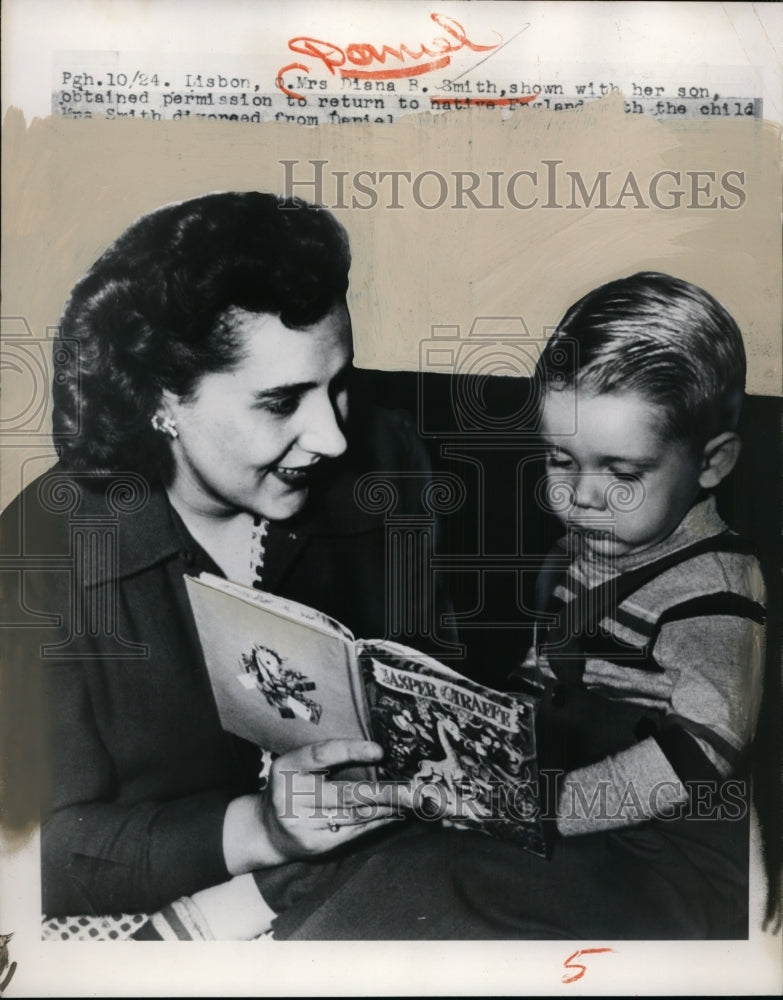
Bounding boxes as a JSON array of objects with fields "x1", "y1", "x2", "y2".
[{"x1": 3, "y1": 192, "x2": 450, "y2": 916}]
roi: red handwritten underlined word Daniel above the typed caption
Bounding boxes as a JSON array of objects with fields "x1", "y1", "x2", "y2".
[{"x1": 275, "y1": 14, "x2": 500, "y2": 98}]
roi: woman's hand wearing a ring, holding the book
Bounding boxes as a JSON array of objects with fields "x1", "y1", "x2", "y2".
[{"x1": 223, "y1": 740, "x2": 400, "y2": 875}]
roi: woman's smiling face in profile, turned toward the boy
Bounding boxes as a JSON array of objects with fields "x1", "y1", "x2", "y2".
[{"x1": 161, "y1": 303, "x2": 353, "y2": 520}]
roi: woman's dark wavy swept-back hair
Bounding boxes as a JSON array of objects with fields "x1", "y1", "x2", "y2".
[{"x1": 53, "y1": 191, "x2": 350, "y2": 475}]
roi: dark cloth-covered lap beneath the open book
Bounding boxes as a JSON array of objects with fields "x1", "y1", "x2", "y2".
[{"x1": 257, "y1": 824, "x2": 747, "y2": 940}]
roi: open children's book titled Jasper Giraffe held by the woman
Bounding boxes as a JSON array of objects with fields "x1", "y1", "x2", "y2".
[{"x1": 185, "y1": 573, "x2": 545, "y2": 856}]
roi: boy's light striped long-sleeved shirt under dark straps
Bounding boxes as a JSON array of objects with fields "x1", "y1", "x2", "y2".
[{"x1": 527, "y1": 497, "x2": 765, "y2": 834}]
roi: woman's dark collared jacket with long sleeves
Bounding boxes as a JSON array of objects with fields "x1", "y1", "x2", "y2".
[{"x1": 0, "y1": 410, "x2": 448, "y2": 915}]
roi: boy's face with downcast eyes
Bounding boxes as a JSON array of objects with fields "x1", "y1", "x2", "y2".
[{"x1": 541, "y1": 389, "x2": 702, "y2": 555}]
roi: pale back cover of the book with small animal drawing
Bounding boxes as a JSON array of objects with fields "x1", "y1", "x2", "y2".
[{"x1": 185, "y1": 574, "x2": 369, "y2": 753}]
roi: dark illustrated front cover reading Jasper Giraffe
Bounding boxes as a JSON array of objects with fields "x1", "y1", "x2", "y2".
[{"x1": 357, "y1": 642, "x2": 545, "y2": 855}]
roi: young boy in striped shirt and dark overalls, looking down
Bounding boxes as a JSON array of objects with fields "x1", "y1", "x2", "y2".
[{"x1": 521, "y1": 273, "x2": 765, "y2": 936}]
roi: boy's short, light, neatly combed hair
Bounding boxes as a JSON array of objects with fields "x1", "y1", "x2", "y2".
[{"x1": 536, "y1": 271, "x2": 746, "y2": 447}]
